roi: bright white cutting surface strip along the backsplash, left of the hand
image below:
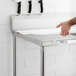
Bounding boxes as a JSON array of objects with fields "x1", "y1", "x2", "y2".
[{"x1": 16, "y1": 28, "x2": 60, "y2": 35}]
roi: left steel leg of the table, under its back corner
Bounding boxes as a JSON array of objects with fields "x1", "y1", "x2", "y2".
[{"x1": 13, "y1": 36, "x2": 16, "y2": 76}]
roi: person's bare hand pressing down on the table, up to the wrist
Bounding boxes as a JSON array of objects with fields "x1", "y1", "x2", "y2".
[{"x1": 56, "y1": 21, "x2": 71, "y2": 36}]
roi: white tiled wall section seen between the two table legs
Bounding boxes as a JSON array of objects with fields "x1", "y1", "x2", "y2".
[{"x1": 17, "y1": 38, "x2": 40, "y2": 76}]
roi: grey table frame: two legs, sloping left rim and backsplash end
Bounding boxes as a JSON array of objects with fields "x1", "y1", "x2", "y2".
[{"x1": 10, "y1": 16, "x2": 76, "y2": 76}]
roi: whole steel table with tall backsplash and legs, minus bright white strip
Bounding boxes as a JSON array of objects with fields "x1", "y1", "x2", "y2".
[{"x1": 11, "y1": 13, "x2": 76, "y2": 76}]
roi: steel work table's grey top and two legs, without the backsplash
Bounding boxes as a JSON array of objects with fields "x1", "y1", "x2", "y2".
[{"x1": 13, "y1": 31, "x2": 76, "y2": 76}]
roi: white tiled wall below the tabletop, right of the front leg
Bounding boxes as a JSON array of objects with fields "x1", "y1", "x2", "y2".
[{"x1": 45, "y1": 44, "x2": 76, "y2": 76}]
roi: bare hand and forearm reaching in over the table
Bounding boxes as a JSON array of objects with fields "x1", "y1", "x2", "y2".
[{"x1": 56, "y1": 17, "x2": 76, "y2": 36}]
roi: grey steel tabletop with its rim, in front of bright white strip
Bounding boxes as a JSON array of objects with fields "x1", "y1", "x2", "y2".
[{"x1": 14, "y1": 32, "x2": 76, "y2": 46}]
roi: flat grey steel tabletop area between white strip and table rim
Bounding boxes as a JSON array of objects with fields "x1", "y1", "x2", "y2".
[{"x1": 25, "y1": 34, "x2": 76, "y2": 42}]
